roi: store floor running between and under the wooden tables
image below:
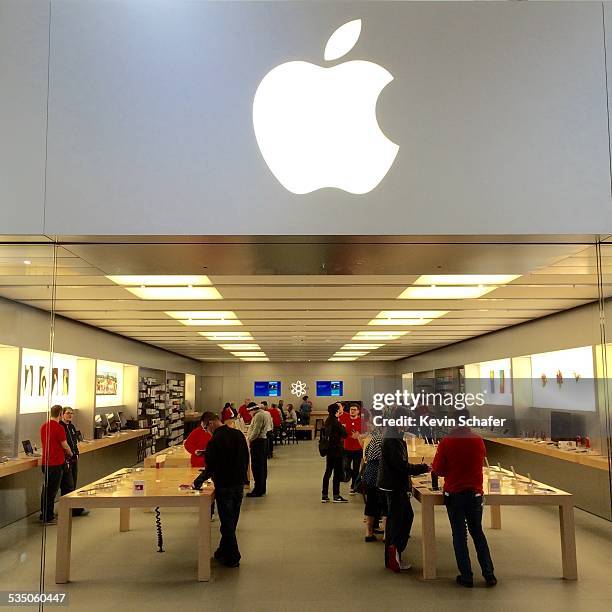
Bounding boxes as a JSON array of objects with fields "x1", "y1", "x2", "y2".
[{"x1": 0, "y1": 442, "x2": 612, "y2": 612}]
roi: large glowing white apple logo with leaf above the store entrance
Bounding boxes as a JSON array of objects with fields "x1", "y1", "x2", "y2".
[{"x1": 253, "y1": 19, "x2": 399, "y2": 194}]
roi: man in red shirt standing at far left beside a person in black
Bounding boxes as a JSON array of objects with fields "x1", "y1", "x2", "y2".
[{"x1": 40, "y1": 405, "x2": 72, "y2": 525}]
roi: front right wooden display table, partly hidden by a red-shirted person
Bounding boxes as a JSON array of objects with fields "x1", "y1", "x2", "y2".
[{"x1": 412, "y1": 468, "x2": 578, "y2": 580}]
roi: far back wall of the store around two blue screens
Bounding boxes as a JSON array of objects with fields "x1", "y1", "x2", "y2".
[{"x1": 203, "y1": 361, "x2": 395, "y2": 411}]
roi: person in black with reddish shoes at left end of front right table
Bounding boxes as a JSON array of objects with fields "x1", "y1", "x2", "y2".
[{"x1": 377, "y1": 410, "x2": 429, "y2": 572}]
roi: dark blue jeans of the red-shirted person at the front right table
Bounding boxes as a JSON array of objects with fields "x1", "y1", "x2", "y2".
[{"x1": 444, "y1": 491, "x2": 493, "y2": 580}]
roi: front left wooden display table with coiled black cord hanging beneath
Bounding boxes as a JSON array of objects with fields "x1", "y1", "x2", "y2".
[{"x1": 55, "y1": 468, "x2": 214, "y2": 584}]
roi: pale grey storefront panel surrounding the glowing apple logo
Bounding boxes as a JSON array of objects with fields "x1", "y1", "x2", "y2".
[{"x1": 0, "y1": 0, "x2": 612, "y2": 235}]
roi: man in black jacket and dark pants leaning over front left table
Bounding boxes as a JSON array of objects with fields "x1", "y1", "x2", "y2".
[{"x1": 193, "y1": 412, "x2": 249, "y2": 567}]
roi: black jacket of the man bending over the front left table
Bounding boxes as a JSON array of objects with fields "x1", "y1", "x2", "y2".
[{"x1": 198, "y1": 425, "x2": 249, "y2": 488}]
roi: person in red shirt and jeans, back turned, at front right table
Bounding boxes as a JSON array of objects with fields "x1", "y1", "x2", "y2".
[{"x1": 431, "y1": 410, "x2": 497, "y2": 587}]
